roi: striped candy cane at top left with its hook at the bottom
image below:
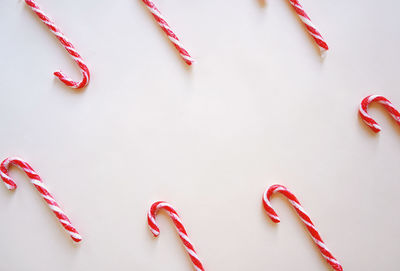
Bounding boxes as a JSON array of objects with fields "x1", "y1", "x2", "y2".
[{"x1": 25, "y1": 0, "x2": 90, "y2": 88}]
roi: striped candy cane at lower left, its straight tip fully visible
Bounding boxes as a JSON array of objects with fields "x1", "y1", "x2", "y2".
[{"x1": 0, "y1": 157, "x2": 82, "y2": 242}]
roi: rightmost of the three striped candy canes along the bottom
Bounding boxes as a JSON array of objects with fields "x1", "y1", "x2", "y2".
[{"x1": 263, "y1": 184, "x2": 343, "y2": 271}]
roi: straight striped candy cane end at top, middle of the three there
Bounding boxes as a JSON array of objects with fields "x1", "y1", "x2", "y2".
[{"x1": 142, "y1": 0, "x2": 194, "y2": 65}]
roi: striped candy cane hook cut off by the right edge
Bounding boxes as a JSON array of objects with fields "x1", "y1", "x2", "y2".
[{"x1": 358, "y1": 95, "x2": 400, "y2": 133}]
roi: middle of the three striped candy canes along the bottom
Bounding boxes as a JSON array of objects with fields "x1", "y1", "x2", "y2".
[{"x1": 147, "y1": 201, "x2": 204, "y2": 271}]
